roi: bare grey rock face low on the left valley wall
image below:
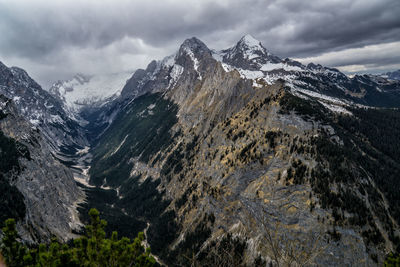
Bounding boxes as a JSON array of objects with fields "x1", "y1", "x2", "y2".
[{"x1": 0, "y1": 95, "x2": 84, "y2": 243}]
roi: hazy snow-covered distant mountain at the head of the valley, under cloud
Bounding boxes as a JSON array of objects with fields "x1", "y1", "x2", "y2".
[{"x1": 49, "y1": 72, "x2": 132, "y2": 111}]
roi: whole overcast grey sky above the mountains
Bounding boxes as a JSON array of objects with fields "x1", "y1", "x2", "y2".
[{"x1": 0, "y1": 0, "x2": 400, "y2": 87}]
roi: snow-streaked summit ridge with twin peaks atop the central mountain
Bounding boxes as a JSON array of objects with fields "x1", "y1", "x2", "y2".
[{"x1": 121, "y1": 35, "x2": 400, "y2": 112}]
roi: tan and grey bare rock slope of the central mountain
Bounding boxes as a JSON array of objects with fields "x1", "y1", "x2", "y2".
[{"x1": 156, "y1": 80, "x2": 371, "y2": 266}]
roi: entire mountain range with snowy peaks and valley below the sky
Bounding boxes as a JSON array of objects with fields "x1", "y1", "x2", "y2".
[{"x1": 0, "y1": 35, "x2": 400, "y2": 266}]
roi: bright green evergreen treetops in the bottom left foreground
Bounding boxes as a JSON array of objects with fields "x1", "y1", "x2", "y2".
[{"x1": 0, "y1": 209, "x2": 155, "y2": 267}]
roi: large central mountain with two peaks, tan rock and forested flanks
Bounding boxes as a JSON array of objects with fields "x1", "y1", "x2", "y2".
[{"x1": 89, "y1": 36, "x2": 400, "y2": 266}]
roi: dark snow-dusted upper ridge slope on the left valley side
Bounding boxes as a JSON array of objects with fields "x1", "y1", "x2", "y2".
[{"x1": 0, "y1": 62, "x2": 87, "y2": 155}]
